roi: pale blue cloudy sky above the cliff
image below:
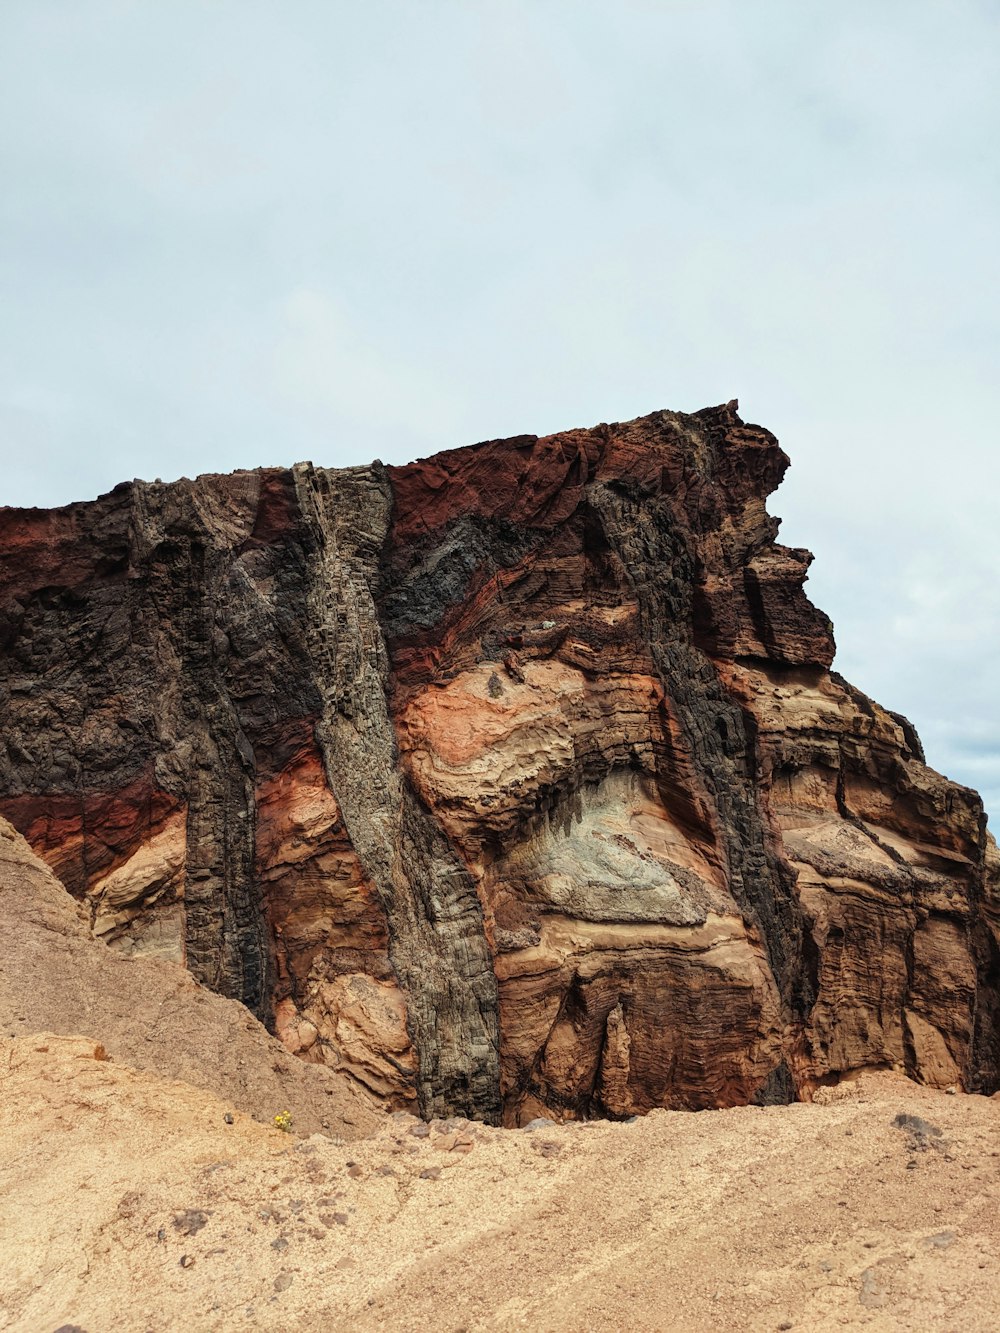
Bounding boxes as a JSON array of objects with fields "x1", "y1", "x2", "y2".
[{"x1": 0, "y1": 0, "x2": 1000, "y2": 813}]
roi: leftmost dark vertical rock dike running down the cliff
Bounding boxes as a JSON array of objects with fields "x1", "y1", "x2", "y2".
[{"x1": 129, "y1": 475, "x2": 272, "y2": 1021}]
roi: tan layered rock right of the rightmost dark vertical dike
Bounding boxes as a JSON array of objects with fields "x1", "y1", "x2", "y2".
[{"x1": 727, "y1": 664, "x2": 995, "y2": 1086}]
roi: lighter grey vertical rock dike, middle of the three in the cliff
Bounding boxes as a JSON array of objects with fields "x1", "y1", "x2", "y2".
[{"x1": 295, "y1": 464, "x2": 500, "y2": 1120}]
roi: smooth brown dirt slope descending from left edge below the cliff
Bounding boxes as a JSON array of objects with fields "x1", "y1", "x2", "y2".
[{"x1": 0, "y1": 818, "x2": 384, "y2": 1137}]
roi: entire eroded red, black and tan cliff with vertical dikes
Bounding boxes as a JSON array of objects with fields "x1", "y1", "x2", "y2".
[{"x1": 0, "y1": 404, "x2": 1000, "y2": 1124}]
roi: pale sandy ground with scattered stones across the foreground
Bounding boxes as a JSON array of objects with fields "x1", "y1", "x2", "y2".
[{"x1": 0, "y1": 1034, "x2": 1000, "y2": 1333}]
